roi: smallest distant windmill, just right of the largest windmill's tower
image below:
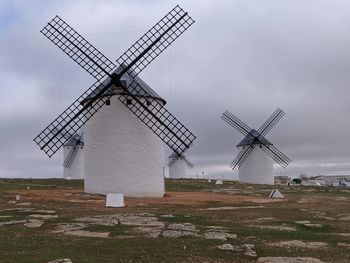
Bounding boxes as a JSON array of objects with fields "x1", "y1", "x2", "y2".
[{"x1": 168, "y1": 152, "x2": 193, "y2": 178}]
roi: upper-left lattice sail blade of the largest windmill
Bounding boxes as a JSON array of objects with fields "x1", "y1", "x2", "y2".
[{"x1": 40, "y1": 16, "x2": 116, "y2": 80}]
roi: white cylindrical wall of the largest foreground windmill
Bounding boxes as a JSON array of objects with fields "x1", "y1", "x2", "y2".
[{"x1": 84, "y1": 95, "x2": 164, "y2": 197}]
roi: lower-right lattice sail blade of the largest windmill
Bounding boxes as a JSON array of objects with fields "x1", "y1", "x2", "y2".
[{"x1": 119, "y1": 81, "x2": 196, "y2": 155}]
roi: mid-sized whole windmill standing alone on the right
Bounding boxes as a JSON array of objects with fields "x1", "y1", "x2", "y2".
[{"x1": 221, "y1": 109, "x2": 290, "y2": 184}]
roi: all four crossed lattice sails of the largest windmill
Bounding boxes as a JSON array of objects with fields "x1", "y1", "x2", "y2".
[{"x1": 34, "y1": 6, "x2": 196, "y2": 157}]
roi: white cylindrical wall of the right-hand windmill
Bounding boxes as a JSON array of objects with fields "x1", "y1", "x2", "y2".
[{"x1": 238, "y1": 146, "x2": 274, "y2": 185}]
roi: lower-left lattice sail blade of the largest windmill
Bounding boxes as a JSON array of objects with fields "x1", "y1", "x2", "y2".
[{"x1": 34, "y1": 81, "x2": 111, "y2": 157}]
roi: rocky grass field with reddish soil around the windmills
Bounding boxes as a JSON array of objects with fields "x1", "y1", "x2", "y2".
[{"x1": 0, "y1": 179, "x2": 350, "y2": 263}]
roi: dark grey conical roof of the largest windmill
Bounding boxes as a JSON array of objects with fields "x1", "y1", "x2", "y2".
[{"x1": 85, "y1": 64, "x2": 166, "y2": 105}]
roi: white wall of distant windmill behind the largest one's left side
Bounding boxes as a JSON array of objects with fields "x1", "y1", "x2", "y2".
[{"x1": 63, "y1": 145, "x2": 84, "y2": 179}]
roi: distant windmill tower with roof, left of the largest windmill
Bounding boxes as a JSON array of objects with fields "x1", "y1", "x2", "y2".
[{"x1": 63, "y1": 132, "x2": 84, "y2": 179}]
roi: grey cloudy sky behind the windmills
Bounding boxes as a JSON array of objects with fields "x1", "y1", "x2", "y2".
[{"x1": 0, "y1": 0, "x2": 350, "y2": 177}]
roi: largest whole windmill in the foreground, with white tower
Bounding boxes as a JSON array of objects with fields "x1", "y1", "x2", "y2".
[{"x1": 34, "y1": 6, "x2": 196, "y2": 196}]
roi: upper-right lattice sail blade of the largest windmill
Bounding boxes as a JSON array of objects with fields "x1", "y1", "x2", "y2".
[{"x1": 117, "y1": 5, "x2": 194, "y2": 78}]
